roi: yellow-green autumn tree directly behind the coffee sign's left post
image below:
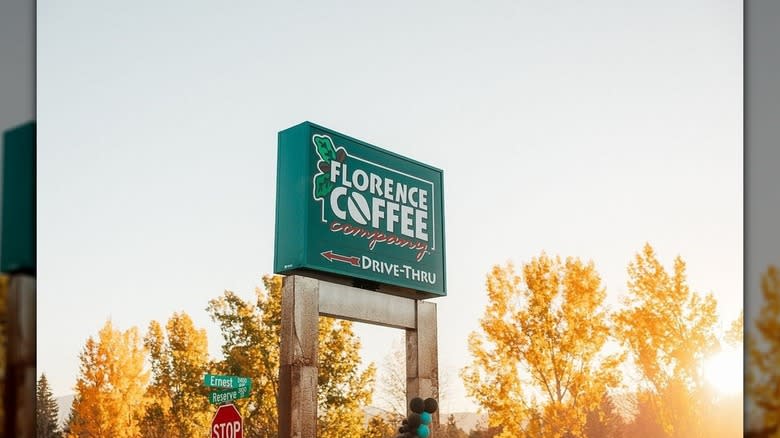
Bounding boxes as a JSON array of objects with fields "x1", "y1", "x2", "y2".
[{"x1": 208, "y1": 276, "x2": 375, "y2": 438}]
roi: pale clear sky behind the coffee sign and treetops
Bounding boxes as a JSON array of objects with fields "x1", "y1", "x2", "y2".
[{"x1": 37, "y1": 0, "x2": 743, "y2": 410}]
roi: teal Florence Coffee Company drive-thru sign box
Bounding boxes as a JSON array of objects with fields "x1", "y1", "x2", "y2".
[{"x1": 274, "y1": 122, "x2": 447, "y2": 298}]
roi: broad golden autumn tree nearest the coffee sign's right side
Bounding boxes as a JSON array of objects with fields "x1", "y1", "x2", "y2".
[{"x1": 461, "y1": 254, "x2": 621, "y2": 437}]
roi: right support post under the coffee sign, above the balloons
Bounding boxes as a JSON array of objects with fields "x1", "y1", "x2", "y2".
[{"x1": 406, "y1": 301, "x2": 439, "y2": 429}]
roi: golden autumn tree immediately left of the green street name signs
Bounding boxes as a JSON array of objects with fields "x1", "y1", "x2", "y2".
[{"x1": 143, "y1": 312, "x2": 211, "y2": 438}]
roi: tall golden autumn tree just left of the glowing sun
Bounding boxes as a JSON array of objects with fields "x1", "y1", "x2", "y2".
[{"x1": 615, "y1": 244, "x2": 718, "y2": 438}]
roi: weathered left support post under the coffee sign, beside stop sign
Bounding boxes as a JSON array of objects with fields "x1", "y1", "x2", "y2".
[{"x1": 278, "y1": 275, "x2": 319, "y2": 438}]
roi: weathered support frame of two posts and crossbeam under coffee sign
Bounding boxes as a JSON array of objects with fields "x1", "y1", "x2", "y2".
[{"x1": 278, "y1": 275, "x2": 439, "y2": 438}]
